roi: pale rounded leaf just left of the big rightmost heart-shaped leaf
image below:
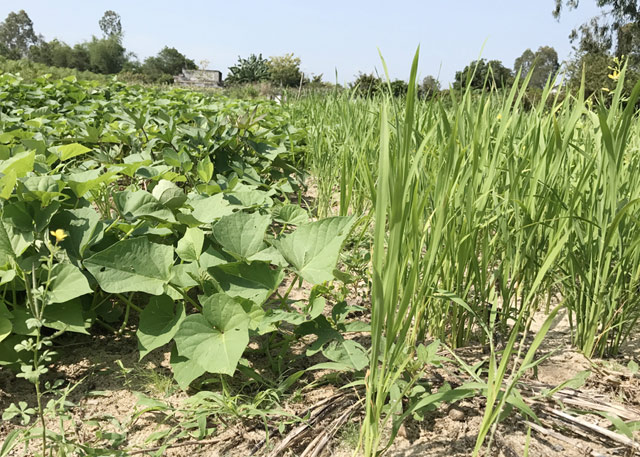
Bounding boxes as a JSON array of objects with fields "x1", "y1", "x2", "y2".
[{"x1": 213, "y1": 212, "x2": 271, "y2": 259}]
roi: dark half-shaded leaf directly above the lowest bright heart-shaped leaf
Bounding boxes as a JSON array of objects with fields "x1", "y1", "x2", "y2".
[{"x1": 207, "y1": 262, "x2": 284, "y2": 305}]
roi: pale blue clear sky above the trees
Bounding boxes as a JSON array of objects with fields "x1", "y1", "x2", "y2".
[{"x1": 0, "y1": 0, "x2": 599, "y2": 87}]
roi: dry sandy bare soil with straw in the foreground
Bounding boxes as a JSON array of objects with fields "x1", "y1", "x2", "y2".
[{"x1": 0, "y1": 300, "x2": 640, "y2": 457}]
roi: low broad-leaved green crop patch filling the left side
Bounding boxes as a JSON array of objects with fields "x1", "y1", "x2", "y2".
[{"x1": 0, "y1": 74, "x2": 367, "y2": 455}]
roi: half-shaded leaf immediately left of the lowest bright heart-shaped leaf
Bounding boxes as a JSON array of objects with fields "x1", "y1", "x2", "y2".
[{"x1": 136, "y1": 295, "x2": 185, "y2": 360}]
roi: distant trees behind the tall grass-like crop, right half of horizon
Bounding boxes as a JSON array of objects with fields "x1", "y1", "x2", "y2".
[{"x1": 351, "y1": 0, "x2": 640, "y2": 98}]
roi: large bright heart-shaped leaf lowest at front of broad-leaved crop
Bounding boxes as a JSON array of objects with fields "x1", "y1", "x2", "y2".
[{"x1": 175, "y1": 294, "x2": 249, "y2": 376}]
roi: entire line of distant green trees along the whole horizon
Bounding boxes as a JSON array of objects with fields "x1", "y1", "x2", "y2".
[{"x1": 0, "y1": 0, "x2": 640, "y2": 98}]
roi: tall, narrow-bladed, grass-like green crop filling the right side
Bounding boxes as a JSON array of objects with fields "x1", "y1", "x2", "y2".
[{"x1": 288, "y1": 50, "x2": 640, "y2": 456}]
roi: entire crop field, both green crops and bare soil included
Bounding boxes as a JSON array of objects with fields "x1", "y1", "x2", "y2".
[{"x1": 0, "y1": 59, "x2": 640, "y2": 457}]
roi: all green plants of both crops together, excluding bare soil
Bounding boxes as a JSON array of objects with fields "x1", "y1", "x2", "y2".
[{"x1": 0, "y1": 55, "x2": 640, "y2": 457}]
